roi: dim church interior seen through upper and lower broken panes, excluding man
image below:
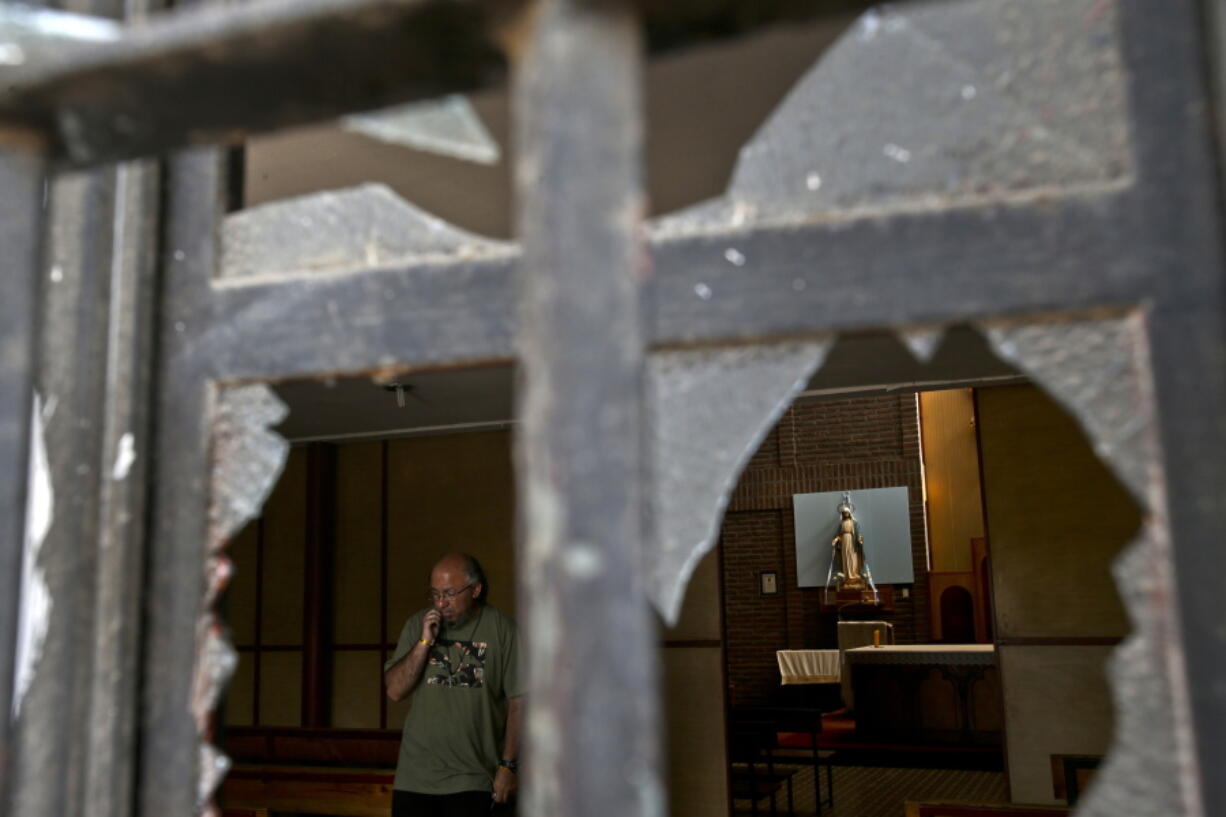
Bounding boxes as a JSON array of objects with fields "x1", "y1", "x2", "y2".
[{"x1": 210, "y1": 3, "x2": 1140, "y2": 817}]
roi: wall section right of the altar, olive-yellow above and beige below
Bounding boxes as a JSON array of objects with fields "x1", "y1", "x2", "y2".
[{"x1": 978, "y1": 385, "x2": 1140, "y2": 804}]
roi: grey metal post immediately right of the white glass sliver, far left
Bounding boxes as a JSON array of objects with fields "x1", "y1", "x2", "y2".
[{"x1": 12, "y1": 155, "x2": 115, "y2": 816}]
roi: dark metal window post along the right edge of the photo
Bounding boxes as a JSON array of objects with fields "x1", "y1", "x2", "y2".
[{"x1": 1123, "y1": 0, "x2": 1226, "y2": 815}]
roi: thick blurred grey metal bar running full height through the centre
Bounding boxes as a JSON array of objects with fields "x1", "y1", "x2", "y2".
[{"x1": 514, "y1": 0, "x2": 663, "y2": 817}]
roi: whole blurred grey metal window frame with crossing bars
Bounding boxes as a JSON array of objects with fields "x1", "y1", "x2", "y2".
[{"x1": 0, "y1": 0, "x2": 1226, "y2": 815}]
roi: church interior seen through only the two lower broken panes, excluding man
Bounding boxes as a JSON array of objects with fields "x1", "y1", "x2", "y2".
[{"x1": 221, "y1": 350, "x2": 1139, "y2": 815}]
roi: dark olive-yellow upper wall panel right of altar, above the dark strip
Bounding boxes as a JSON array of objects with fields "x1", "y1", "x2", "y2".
[{"x1": 978, "y1": 385, "x2": 1140, "y2": 639}]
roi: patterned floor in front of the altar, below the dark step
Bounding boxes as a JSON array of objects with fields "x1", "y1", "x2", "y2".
[{"x1": 734, "y1": 765, "x2": 1008, "y2": 817}]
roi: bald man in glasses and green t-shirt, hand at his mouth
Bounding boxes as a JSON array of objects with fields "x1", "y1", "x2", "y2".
[{"x1": 384, "y1": 553, "x2": 524, "y2": 817}]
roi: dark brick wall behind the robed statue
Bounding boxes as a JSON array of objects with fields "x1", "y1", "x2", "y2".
[{"x1": 721, "y1": 394, "x2": 929, "y2": 704}]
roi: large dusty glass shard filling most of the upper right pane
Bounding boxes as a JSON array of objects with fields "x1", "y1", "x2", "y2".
[{"x1": 656, "y1": 0, "x2": 1132, "y2": 236}]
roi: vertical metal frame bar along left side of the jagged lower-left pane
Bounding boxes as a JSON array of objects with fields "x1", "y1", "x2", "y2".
[{"x1": 135, "y1": 150, "x2": 224, "y2": 817}]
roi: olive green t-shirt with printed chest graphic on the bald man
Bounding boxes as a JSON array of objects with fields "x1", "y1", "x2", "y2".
[{"x1": 384, "y1": 605, "x2": 522, "y2": 794}]
